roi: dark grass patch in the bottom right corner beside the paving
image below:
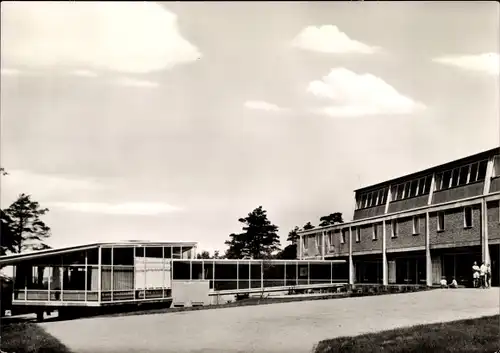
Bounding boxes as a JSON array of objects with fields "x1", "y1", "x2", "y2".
[{"x1": 314, "y1": 315, "x2": 500, "y2": 353}]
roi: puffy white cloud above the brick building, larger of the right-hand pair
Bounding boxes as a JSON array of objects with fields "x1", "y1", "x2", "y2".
[{"x1": 307, "y1": 68, "x2": 424, "y2": 117}]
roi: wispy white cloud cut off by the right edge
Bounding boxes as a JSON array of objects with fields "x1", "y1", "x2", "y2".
[{"x1": 432, "y1": 53, "x2": 500, "y2": 75}]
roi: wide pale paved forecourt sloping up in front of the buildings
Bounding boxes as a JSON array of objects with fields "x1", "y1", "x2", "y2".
[{"x1": 42, "y1": 288, "x2": 500, "y2": 353}]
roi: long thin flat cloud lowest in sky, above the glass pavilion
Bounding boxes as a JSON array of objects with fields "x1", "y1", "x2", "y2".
[{"x1": 50, "y1": 202, "x2": 180, "y2": 216}]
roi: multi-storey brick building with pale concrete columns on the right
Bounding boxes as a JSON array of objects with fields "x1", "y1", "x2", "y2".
[{"x1": 297, "y1": 148, "x2": 500, "y2": 286}]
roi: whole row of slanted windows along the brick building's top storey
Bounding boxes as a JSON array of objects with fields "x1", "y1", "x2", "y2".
[{"x1": 356, "y1": 156, "x2": 500, "y2": 209}]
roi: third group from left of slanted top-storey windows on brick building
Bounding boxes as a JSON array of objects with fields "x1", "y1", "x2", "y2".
[{"x1": 436, "y1": 160, "x2": 488, "y2": 191}]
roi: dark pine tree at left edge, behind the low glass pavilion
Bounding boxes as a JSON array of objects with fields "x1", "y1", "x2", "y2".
[{"x1": 0, "y1": 168, "x2": 50, "y2": 255}]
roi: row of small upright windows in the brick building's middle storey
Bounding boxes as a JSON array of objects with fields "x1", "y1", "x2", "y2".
[{"x1": 306, "y1": 207, "x2": 473, "y2": 249}]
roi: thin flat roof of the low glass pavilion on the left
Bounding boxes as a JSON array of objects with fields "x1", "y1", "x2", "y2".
[{"x1": 0, "y1": 240, "x2": 198, "y2": 265}]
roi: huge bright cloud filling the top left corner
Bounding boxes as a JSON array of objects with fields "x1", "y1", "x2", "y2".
[{"x1": 1, "y1": 1, "x2": 201, "y2": 73}]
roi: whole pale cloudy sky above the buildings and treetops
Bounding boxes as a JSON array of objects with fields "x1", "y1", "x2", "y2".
[{"x1": 0, "y1": 1, "x2": 500, "y2": 251}]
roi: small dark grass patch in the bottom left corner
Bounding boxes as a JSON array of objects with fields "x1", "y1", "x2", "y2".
[{"x1": 0, "y1": 320, "x2": 71, "y2": 353}]
